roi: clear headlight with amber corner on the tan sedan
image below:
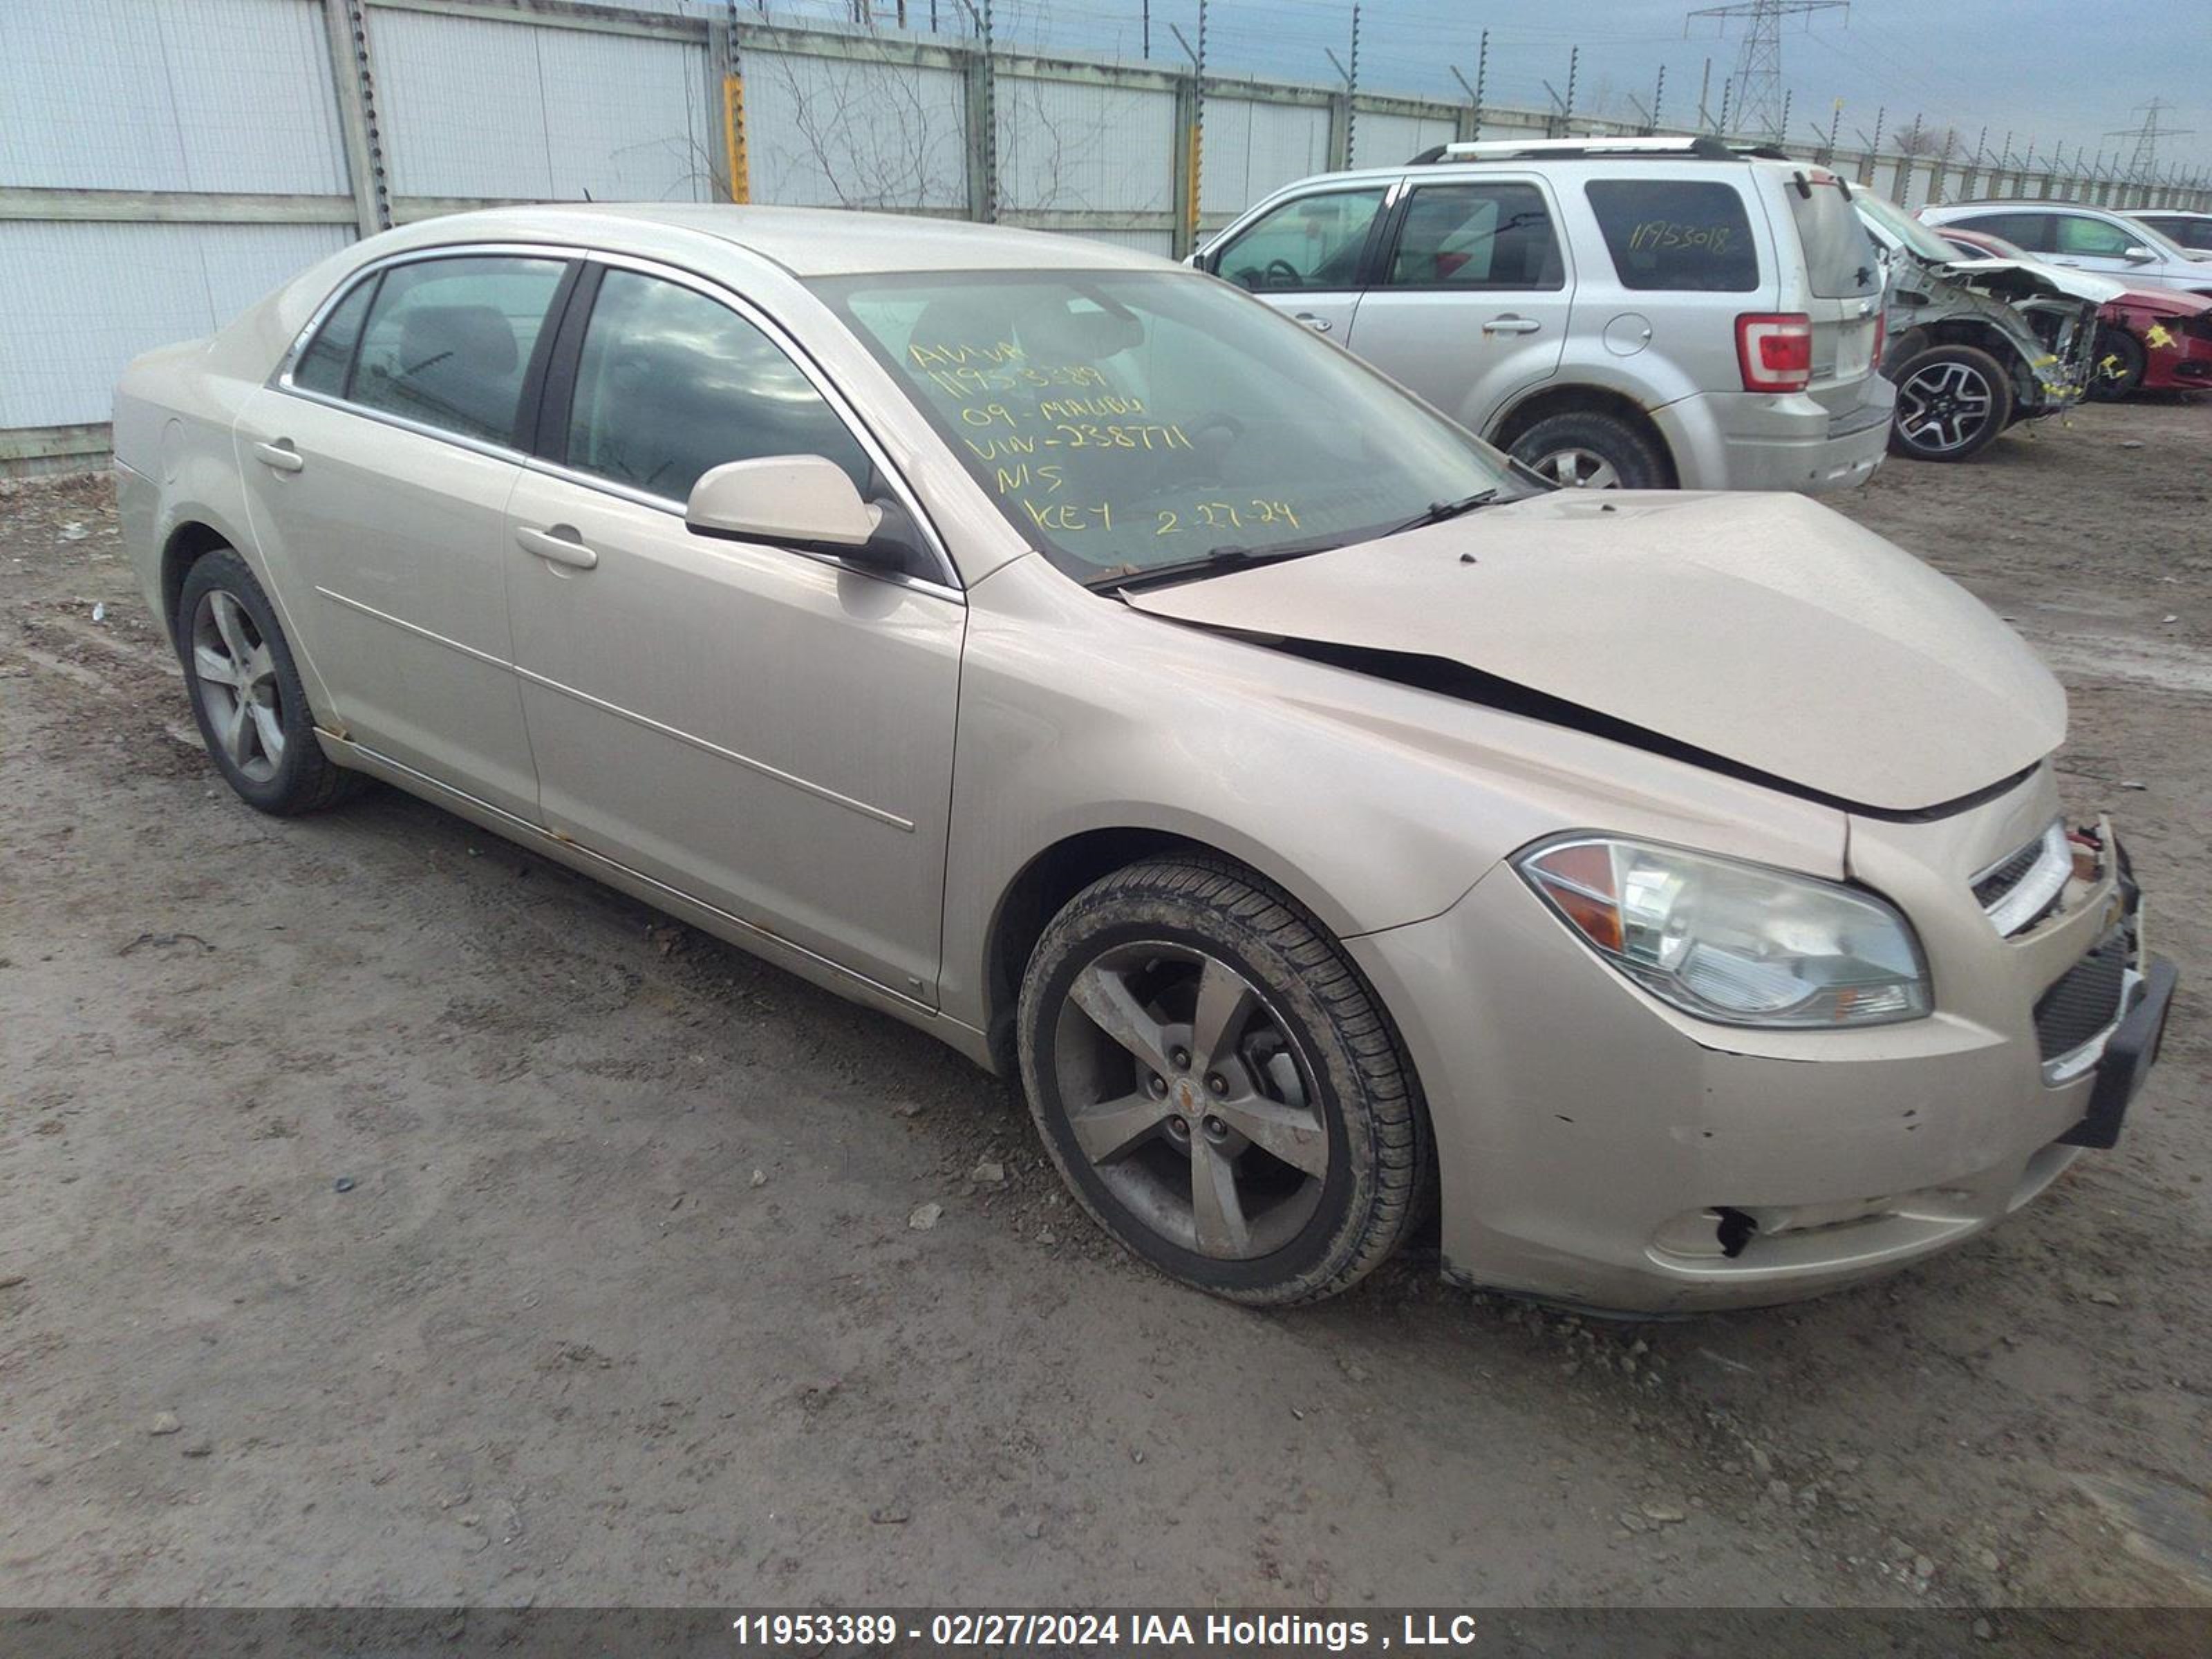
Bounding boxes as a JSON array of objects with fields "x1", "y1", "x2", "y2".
[{"x1": 1513, "y1": 836, "x2": 1933, "y2": 1029}]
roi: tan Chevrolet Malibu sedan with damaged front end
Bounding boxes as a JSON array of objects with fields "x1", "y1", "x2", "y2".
[{"x1": 115, "y1": 206, "x2": 2175, "y2": 1312}]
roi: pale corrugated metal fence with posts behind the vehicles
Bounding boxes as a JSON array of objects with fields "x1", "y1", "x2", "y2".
[{"x1": 0, "y1": 0, "x2": 2212, "y2": 471}]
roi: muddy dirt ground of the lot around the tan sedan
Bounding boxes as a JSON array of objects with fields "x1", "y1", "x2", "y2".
[{"x1": 0, "y1": 402, "x2": 2212, "y2": 1644}]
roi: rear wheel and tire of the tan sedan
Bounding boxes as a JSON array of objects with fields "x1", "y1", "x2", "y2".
[{"x1": 175, "y1": 546, "x2": 358, "y2": 818}]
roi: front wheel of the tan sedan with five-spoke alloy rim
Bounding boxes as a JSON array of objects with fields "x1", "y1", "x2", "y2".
[{"x1": 1020, "y1": 861, "x2": 1427, "y2": 1305}]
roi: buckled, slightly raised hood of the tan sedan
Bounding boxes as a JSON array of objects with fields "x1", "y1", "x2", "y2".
[{"x1": 1128, "y1": 491, "x2": 2066, "y2": 812}]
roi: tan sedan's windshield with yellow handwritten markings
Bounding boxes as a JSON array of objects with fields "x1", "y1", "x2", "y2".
[{"x1": 814, "y1": 270, "x2": 1517, "y2": 582}]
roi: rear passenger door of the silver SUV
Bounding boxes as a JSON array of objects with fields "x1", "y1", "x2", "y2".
[{"x1": 1351, "y1": 177, "x2": 1573, "y2": 431}]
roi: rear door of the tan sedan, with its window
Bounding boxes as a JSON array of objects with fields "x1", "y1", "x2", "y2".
[{"x1": 234, "y1": 254, "x2": 571, "y2": 821}]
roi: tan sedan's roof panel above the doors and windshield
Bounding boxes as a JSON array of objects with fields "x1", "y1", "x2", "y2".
[{"x1": 354, "y1": 201, "x2": 1174, "y2": 276}]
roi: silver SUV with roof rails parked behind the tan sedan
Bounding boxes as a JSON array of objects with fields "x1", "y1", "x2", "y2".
[{"x1": 1194, "y1": 140, "x2": 1895, "y2": 491}]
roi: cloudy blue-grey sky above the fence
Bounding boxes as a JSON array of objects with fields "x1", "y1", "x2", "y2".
[{"x1": 772, "y1": 0, "x2": 2212, "y2": 170}]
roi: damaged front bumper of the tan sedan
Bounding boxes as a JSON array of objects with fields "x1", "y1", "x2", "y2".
[{"x1": 1351, "y1": 787, "x2": 2172, "y2": 1314}]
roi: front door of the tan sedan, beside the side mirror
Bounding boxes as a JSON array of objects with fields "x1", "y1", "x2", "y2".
[{"x1": 505, "y1": 265, "x2": 966, "y2": 1004}]
